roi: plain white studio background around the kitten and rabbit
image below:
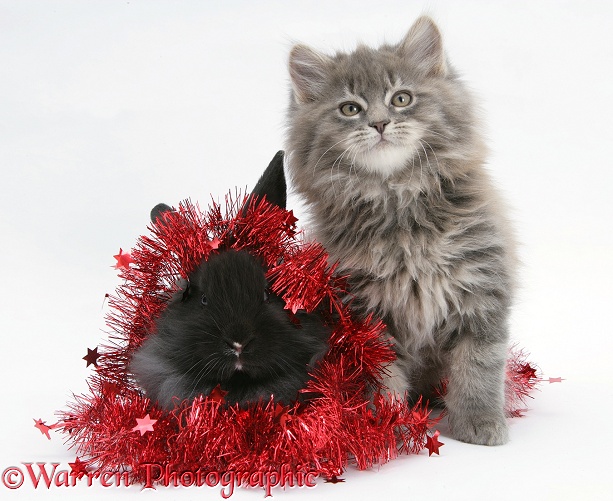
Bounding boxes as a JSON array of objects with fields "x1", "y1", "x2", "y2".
[{"x1": 0, "y1": 0, "x2": 613, "y2": 500}]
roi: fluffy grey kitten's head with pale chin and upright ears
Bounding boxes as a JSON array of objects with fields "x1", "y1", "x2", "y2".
[{"x1": 288, "y1": 17, "x2": 478, "y2": 189}]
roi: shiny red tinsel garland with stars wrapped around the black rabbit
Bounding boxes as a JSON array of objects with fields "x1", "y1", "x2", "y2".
[{"x1": 55, "y1": 193, "x2": 536, "y2": 482}]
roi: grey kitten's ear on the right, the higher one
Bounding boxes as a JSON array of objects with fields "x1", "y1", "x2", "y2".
[{"x1": 398, "y1": 16, "x2": 448, "y2": 77}]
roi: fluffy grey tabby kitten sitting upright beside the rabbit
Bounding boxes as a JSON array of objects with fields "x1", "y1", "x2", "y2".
[{"x1": 286, "y1": 17, "x2": 514, "y2": 445}]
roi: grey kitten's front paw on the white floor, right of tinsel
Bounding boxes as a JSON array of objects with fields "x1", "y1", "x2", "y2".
[{"x1": 449, "y1": 410, "x2": 509, "y2": 445}]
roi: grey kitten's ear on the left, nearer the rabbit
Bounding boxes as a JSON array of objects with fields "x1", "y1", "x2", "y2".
[{"x1": 289, "y1": 45, "x2": 332, "y2": 103}]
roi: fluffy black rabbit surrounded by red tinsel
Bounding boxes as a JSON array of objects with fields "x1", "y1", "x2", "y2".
[{"x1": 129, "y1": 152, "x2": 330, "y2": 409}]
